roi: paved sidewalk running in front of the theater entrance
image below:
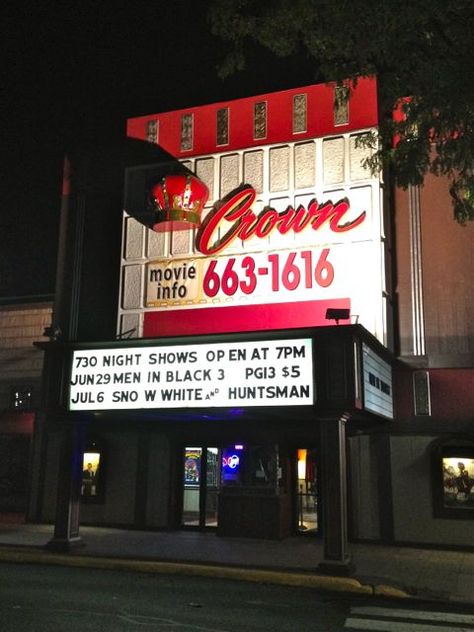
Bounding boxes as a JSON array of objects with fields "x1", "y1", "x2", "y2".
[{"x1": 0, "y1": 524, "x2": 474, "y2": 604}]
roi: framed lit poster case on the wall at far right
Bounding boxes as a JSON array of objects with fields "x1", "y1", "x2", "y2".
[{"x1": 433, "y1": 443, "x2": 474, "y2": 518}]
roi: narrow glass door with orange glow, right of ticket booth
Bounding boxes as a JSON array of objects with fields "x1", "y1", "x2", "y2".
[{"x1": 296, "y1": 448, "x2": 319, "y2": 533}]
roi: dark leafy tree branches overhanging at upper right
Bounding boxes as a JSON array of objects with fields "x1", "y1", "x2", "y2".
[{"x1": 209, "y1": 0, "x2": 474, "y2": 224}]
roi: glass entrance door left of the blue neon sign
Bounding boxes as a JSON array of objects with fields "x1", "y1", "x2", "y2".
[{"x1": 182, "y1": 446, "x2": 220, "y2": 528}]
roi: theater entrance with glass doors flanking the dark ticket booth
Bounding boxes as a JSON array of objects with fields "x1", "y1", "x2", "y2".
[{"x1": 180, "y1": 444, "x2": 321, "y2": 538}]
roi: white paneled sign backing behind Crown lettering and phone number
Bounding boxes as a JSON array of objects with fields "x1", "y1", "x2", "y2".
[{"x1": 119, "y1": 128, "x2": 387, "y2": 343}]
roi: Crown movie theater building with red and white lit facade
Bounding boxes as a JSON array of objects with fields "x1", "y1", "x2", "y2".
[{"x1": 32, "y1": 79, "x2": 474, "y2": 569}]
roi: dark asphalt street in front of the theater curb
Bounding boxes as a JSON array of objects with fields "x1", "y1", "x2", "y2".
[{"x1": 0, "y1": 564, "x2": 474, "y2": 632}]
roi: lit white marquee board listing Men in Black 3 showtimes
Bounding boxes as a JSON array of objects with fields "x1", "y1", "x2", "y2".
[{"x1": 69, "y1": 339, "x2": 314, "y2": 411}]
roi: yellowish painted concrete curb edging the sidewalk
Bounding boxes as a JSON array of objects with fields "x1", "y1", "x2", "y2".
[{"x1": 0, "y1": 546, "x2": 411, "y2": 598}]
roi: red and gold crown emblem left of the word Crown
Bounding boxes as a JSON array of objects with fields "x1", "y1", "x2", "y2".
[{"x1": 150, "y1": 174, "x2": 209, "y2": 233}]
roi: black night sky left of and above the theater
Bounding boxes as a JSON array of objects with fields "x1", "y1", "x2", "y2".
[{"x1": 0, "y1": 1, "x2": 316, "y2": 298}]
